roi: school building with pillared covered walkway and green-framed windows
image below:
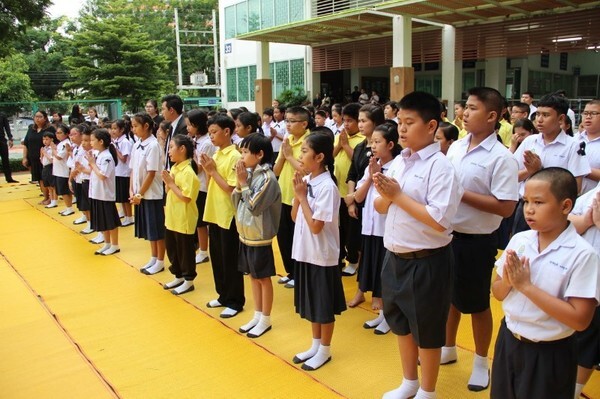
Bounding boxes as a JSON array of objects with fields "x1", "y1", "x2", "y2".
[{"x1": 219, "y1": 0, "x2": 600, "y2": 116}]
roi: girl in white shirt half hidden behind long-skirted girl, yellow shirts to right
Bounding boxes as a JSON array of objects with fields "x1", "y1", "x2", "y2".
[{"x1": 110, "y1": 119, "x2": 134, "y2": 227}]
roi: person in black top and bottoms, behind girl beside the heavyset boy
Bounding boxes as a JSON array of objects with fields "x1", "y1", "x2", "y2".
[{"x1": 336, "y1": 104, "x2": 385, "y2": 290}]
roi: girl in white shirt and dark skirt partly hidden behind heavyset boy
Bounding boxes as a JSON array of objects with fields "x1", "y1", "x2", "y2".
[{"x1": 348, "y1": 122, "x2": 402, "y2": 335}]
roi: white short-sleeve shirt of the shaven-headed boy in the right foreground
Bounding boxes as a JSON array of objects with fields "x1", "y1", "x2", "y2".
[{"x1": 496, "y1": 224, "x2": 600, "y2": 341}]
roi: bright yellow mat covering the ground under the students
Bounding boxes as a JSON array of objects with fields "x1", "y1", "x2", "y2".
[{"x1": 0, "y1": 179, "x2": 600, "y2": 399}]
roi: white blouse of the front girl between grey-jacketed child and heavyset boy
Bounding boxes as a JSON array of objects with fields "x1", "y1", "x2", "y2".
[{"x1": 292, "y1": 171, "x2": 340, "y2": 267}]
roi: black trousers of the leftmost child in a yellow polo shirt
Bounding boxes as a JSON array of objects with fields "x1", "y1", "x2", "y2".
[{"x1": 165, "y1": 229, "x2": 197, "y2": 281}]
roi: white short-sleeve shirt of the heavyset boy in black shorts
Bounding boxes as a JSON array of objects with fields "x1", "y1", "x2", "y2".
[{"x1": 383, "y1": 143, "x2": 463, "y2": 253}]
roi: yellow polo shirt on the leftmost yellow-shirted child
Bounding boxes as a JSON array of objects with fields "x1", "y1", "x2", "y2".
[{"x1": 165, "y1": 159, "x2": 200, "y2": 234}]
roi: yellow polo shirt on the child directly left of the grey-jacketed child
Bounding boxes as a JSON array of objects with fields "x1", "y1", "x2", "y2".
[{"x1": 203, "y1": 145, "x2": 242, "y2": 230}]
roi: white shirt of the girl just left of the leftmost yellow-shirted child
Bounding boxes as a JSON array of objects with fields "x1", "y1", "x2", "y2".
[{"x1": 129, "y1": 135, "x2": 164, "y2": 200}]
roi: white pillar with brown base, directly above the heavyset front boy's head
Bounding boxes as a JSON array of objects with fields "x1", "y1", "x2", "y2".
[{"x1": 390, "y1": 15, "x2": 415, "y2": 101}]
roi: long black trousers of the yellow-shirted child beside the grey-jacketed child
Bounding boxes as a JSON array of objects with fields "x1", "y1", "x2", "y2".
[{"x1": 206, "y1": 221, "x2": 246, "y2": 311}]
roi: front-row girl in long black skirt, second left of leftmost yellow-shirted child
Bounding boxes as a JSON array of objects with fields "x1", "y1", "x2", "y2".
[{"x1": 86, "y1": 129, "x2": 121, "y2": 255}]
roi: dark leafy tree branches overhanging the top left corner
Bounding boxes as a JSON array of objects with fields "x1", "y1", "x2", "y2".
[{"x1": 0, "y1": 0, "x2": 52, "y2": 55}]
